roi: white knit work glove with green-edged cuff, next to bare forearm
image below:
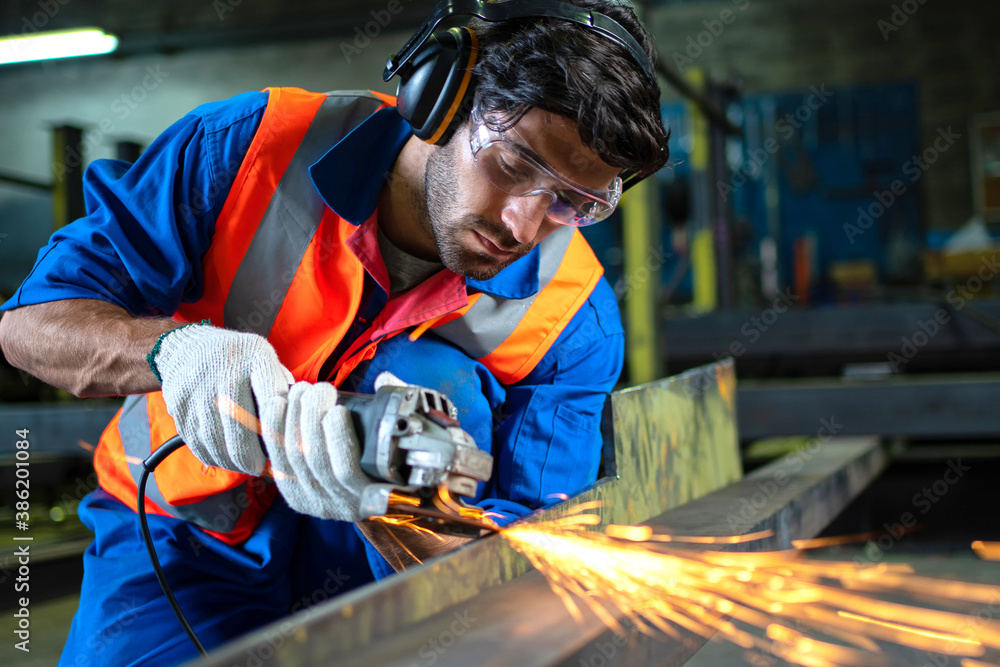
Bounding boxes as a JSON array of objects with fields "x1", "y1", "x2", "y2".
[{"x1": 148, "y1": 324, "x2": 295, "y2": 476}]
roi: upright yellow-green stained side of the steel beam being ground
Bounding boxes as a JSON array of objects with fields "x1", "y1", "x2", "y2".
[{"x1": 193, "y1": 361, "x2": 741, "y2": 667}]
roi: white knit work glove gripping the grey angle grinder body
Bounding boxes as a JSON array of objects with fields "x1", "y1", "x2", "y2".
[{"x1": 261, "y1": 382, "x2": 375, "y2": 522}]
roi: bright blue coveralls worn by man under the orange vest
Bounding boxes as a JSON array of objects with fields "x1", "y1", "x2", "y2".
[{"x1": 3, "y1": 93, "x2": 624, "y2": 667}]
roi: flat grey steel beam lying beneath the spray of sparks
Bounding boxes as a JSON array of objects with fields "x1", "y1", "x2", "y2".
[{"x1": 199, "y1": 438, "x2": 887, "y2": 667}]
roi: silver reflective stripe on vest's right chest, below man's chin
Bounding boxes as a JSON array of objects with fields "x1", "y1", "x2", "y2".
[{"x1": 434, "y1": 227, "x2": 576, "y2": 359}]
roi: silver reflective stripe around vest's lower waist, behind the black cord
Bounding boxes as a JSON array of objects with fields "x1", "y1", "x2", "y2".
[{"x1": 118, "y1": 394, "x2": 248, "y2": 533}]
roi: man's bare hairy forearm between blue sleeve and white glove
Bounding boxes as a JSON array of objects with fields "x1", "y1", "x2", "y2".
[{"x1": 0, "y1": 299, "x2": 180, "y2": 397}]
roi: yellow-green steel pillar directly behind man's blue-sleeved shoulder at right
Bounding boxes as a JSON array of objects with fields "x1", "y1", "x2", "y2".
[{"x1": 622, "y1": 172, "x2": 665, "y2": 385}]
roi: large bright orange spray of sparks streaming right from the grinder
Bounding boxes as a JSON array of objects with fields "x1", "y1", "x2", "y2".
[{"x1": 501, "y1": 512, "x2": 1000, "y2": 667}]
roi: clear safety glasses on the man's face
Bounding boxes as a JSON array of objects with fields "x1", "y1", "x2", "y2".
[{"x1": 469, "y1": 109, "x2": 622, "y2": 227}]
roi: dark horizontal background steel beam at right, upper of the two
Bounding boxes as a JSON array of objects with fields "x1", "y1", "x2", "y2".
[{"x1": 661, "y1": 300, "x2": 1000, "y2": 379}]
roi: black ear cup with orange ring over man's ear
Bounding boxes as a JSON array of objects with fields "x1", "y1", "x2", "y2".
[{"x1": 396, "y1": 27, "x2": 477, "y2": 144}]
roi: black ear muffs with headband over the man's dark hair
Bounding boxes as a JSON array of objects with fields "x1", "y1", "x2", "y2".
[{"x1": 382, "y1": 0, "x2": 656, "y2": 144}]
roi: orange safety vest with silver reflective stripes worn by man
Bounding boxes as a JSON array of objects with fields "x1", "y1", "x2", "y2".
[{"x1": 94, "y1": 88, "x2": 603, "y2": 544}]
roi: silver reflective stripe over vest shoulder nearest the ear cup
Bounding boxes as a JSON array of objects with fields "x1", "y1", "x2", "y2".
[{"x1": 223, "y1": 92, "x2": 383, "y2": 336}]
